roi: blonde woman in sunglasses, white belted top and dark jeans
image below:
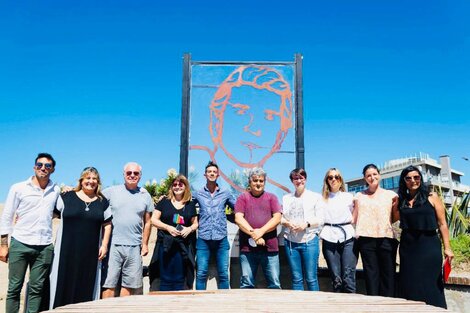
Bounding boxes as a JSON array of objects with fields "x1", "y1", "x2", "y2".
[{"x1": 320, "y1": 168, "x2": 357, "y2": 293}]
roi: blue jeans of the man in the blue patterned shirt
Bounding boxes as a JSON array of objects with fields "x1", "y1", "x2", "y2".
[{"x1": 196, "y1": 237, "x2": 230, "y2": 290}]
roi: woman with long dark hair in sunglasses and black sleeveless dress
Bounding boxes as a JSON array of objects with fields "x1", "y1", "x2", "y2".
[{"x1": 398, "y1": 166, "x2": 454, "y2": 308}]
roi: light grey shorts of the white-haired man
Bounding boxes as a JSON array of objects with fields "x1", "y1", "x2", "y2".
[{"x1": 103, "y1": 245, "x2": 142, "y2": 289}]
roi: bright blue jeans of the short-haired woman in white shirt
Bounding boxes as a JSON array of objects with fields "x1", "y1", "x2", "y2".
[{"x1": 284, "y1": 235, "x2": 320, "y2": 291}]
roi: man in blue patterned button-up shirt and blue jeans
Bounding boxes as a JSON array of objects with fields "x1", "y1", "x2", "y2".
[{"x1": 194, "y1": 161, "x2": 235, "y2": 290}]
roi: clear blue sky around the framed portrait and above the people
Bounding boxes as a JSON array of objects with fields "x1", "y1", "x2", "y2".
[{"x1": 0, "y1": 0, "x2": 470, "y2": 202}]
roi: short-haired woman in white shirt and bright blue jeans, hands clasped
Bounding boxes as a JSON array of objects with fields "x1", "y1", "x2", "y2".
[{"x1": 281, "y1": 168, "x2": 323, "y2": 291}]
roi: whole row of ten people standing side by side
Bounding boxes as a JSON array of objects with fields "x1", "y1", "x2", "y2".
[{"x1": 0, "y1": 153, "x2": 453, "y2": 312}]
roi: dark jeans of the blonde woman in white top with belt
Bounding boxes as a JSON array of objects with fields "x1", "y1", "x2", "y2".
[{"x1": 322, "y1": 239, "x2": 357, "y2": 293}]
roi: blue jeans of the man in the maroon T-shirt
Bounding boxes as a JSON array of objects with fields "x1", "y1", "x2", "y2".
[{"x1": 240, "y1": 251, "x2": 281, "y2": 289}]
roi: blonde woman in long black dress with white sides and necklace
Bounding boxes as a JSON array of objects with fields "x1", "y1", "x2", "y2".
[{"x1": 49, "y1": 167, "x2": 112, "y2": 309}]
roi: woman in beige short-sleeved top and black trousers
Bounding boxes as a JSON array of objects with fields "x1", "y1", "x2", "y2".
[{"x1": 355, "y1": 164, "x2": 398, "y2": 297}]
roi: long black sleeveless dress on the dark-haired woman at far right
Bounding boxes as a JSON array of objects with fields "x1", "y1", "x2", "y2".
[{"x1": 399, "y1": 200, "x2": 447, "y2": 308}]
